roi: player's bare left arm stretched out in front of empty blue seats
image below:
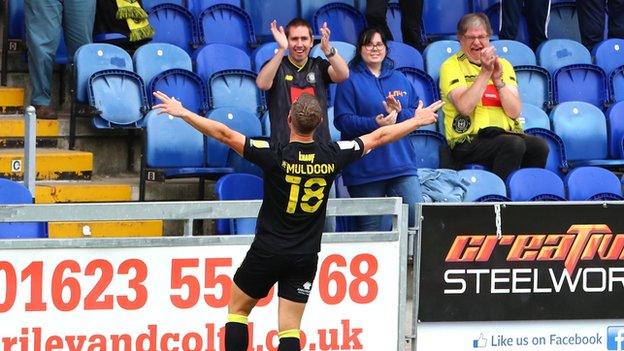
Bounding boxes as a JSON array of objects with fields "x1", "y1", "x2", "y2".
[{"x1": 153, "y1": 91, "x2": 245, "y2": 155}]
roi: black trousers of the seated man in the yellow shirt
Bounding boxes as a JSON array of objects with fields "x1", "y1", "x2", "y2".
[{"x1": 452, "y1": 133, "x2": 549, "y2": 180}]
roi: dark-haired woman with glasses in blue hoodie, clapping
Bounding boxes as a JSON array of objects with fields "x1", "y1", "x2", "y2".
[{"x1": 334, "y1": 28, "x2": 442, "y2": 231}]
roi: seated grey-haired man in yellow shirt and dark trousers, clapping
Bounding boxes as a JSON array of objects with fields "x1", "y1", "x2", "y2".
[{"x1": 440, "y1": 13, "x2": 548, "y2": 180}]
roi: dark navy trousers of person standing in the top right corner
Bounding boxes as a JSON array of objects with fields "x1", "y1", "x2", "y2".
[{"x1": 576, "y1": 0, "x2": 624, "y2": 50}]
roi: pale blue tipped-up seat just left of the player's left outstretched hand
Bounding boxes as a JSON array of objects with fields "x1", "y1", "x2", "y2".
[{"x1": 88, "y1": 69, "x2": 149, "y2": 129}]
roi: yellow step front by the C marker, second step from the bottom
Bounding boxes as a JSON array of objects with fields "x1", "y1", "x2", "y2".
[{"x1": 0, "y1": 148, "x2": 93, "y2": 180}]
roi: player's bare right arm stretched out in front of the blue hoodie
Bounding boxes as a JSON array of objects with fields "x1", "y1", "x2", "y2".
[{"x1": 360, "y1": 100, "x2": 444, "y2": 153}]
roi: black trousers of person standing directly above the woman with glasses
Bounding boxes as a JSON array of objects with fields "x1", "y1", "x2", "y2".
[{"x1": 366, "y1": 0, "x2": 426, "y2": 52}]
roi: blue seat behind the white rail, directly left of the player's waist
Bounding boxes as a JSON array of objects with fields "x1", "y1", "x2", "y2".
[{"x1": 215, "y1": 173, "x2": 264, "y2": 234}]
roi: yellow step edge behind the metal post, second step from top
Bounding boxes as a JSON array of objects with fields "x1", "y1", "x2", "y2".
[{"x1": 0, "y1": 115, "x2": 60, "y2": 148}]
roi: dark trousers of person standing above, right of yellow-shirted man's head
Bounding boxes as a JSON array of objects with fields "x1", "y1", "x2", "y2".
[{"x1": 499, "y1": 0, "x2": 550, "y2": 50}]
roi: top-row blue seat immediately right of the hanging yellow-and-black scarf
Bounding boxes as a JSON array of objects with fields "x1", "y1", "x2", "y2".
[{"x1": 148, "y1": 4, "x2": 198, "y2": 55}]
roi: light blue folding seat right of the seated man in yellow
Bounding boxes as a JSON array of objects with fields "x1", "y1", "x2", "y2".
[{"x1": 550, "y1": 101, "x2": 624, "y2": 167}]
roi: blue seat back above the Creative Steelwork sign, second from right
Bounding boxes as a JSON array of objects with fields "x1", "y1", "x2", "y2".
[{"x1": 506, "y1": 168, "x2": 565, "y2": 201}]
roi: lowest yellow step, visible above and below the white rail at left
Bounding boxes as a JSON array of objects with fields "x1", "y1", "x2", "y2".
[{"x1": 35, "y1": 181, "x2": 164, "y2": 238}]
